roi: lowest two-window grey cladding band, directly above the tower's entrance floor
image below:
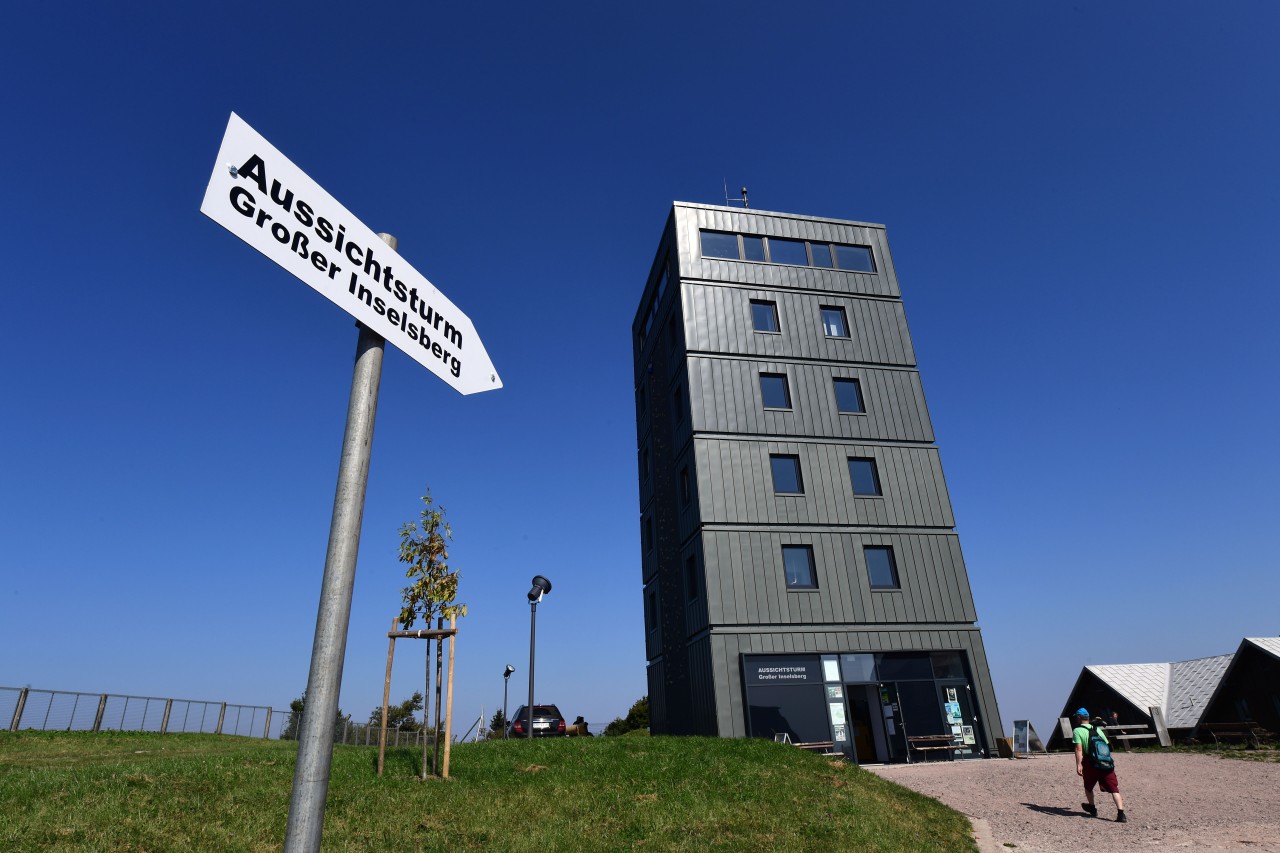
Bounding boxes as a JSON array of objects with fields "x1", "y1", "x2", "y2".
[{"x1": 701, "y1": 530, "x2": 978, "y2": 625}]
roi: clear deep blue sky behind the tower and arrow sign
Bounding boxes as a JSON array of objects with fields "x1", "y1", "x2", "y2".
[{"x1": 0, "y1": 1, "x2": 1280, "y2": 734}]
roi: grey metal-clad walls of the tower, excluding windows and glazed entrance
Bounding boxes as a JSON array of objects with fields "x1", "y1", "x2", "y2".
[{"x1": 632, "y1": 202, "x2": 1002, "y2": 754}]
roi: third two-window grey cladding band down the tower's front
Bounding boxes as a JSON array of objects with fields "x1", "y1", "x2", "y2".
[{"x1": 694, "y1": 438, "x2": 955, "y2": 529}]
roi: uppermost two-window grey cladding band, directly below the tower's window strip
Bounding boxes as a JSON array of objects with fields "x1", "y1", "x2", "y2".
[{"x1": 681, "y1": 282, "x2": 915, "y2": 368}]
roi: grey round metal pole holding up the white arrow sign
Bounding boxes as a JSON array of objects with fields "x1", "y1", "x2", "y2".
[{"x1": 284, "y1": 234, "x2": 396, "y2": 853}]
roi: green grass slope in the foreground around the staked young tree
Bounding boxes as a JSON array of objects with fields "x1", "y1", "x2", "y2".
[{"x1": 0, "y1": 731, "x2": 977, "y2": 853}]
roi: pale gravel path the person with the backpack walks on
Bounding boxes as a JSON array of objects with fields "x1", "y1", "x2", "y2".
[{"x1": 868, "y1": 752, "x2": 1280, "y2": 853}]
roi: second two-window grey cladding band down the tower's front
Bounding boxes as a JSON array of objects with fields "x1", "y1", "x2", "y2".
[{"x1": 689, "y1": 356, "x2": 933, "y2": 442}]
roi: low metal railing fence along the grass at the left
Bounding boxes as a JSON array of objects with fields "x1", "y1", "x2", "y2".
[{"x1": 0, "y1": 686, "x2": 433, "y2": 747}]
